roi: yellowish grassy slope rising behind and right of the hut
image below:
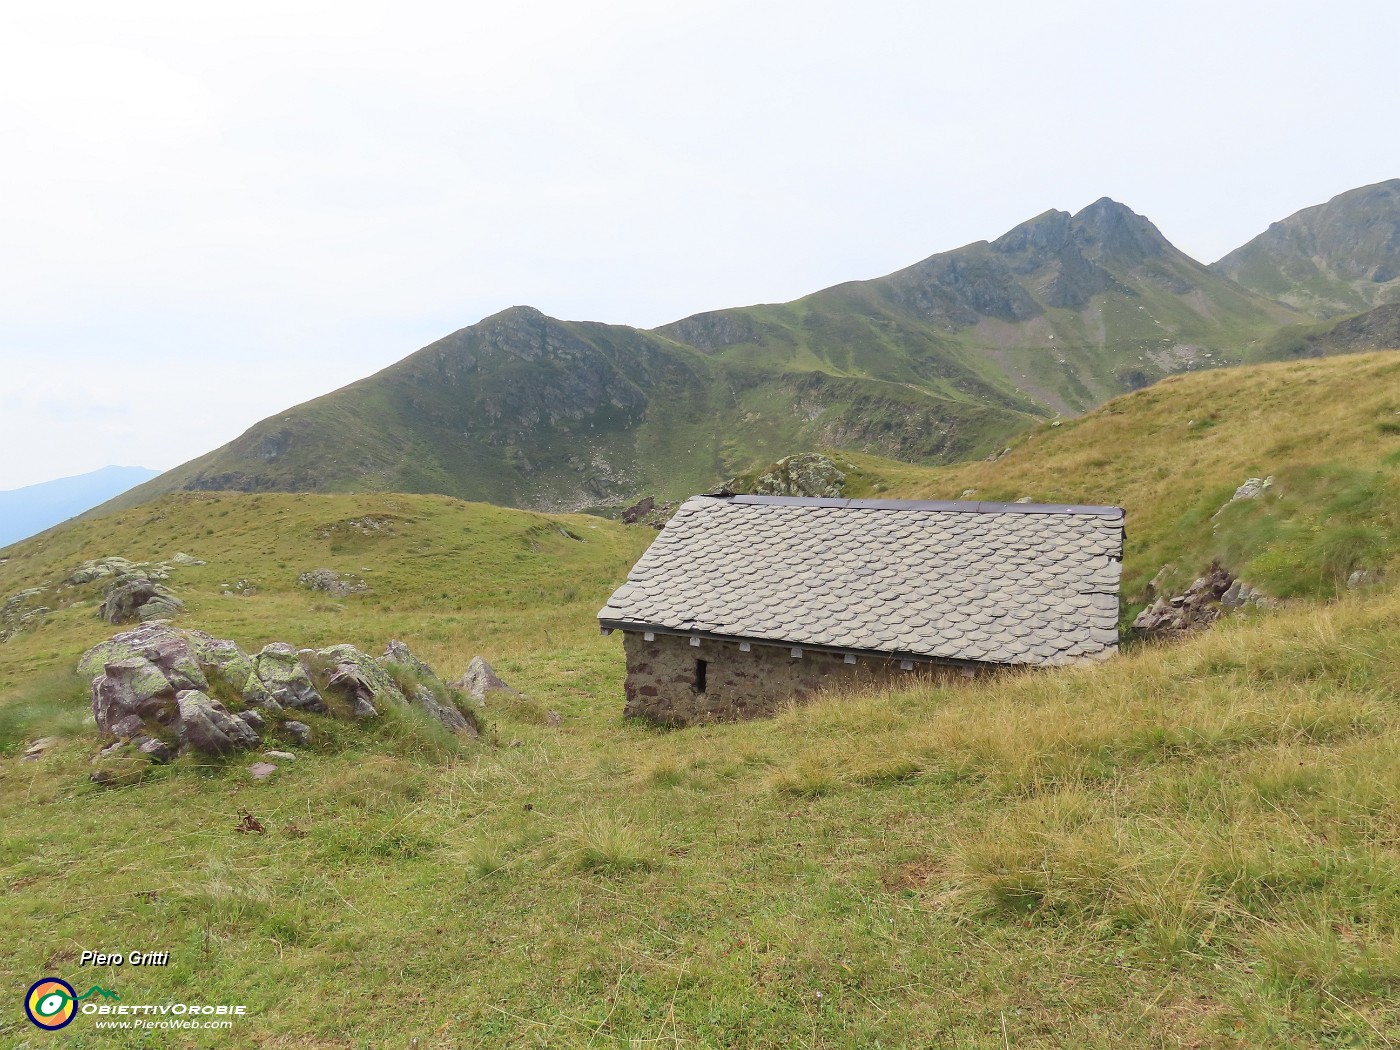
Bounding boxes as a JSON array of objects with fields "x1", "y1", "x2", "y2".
[{"x1": 841, "y1": 351, "x2": 1400, "y2": 615}]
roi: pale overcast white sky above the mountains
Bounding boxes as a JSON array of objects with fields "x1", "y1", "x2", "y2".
[{"x1": 0, "y1": 0, "x2": 1400, "y2": 489}]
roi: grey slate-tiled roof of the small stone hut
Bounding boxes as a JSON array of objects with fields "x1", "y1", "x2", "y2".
[{"x1": 598, "y1": 496, "x2": 1123, "y2": 664}]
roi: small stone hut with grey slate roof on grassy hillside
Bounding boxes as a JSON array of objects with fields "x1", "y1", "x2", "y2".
[{"x1": 598, "y1": 496, "x2": 1123, "y2": 725}]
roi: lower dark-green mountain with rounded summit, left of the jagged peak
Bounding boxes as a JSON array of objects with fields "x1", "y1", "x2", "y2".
[{"x1": 98, "y1": 316, "x2": 1037, "y2": 523}]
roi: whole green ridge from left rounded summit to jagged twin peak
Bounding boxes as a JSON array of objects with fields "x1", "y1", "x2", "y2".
[{"x1": 98, "y1": 197, "x2": 1303, "y2": 510}]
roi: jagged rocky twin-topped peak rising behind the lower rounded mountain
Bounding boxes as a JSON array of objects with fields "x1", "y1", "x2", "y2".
[{"x1": 658, "y1": 197, "x2": 1301, "y2": 413}]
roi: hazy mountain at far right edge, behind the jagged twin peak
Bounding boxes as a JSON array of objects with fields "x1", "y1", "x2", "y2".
[{"x1": 1212, "y1": 179, "x2": 1400, "y2": 318}]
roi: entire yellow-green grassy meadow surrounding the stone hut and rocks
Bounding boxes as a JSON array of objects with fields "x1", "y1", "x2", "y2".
[{"x1": 0, "y1": 356, "x2": 1400, "y2": 1050}]
